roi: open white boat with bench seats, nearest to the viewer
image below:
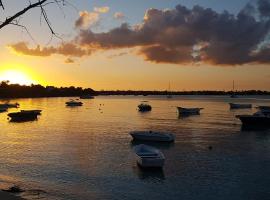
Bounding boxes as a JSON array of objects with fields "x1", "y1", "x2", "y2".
[{"x1": 134, "y1": 144, "x2": 165, "y2": 168}]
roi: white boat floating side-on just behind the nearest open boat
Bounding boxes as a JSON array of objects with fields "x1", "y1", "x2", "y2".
[{"x1": 129, "y1": 131, "x2": 175, "y2": 142}]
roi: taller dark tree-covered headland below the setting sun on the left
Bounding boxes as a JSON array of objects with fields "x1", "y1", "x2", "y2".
[{"x1": 0, "y1": 81, "x2": 96, "y2": 98}]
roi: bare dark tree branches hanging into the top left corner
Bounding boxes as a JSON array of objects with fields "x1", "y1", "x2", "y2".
[{"x1": 0, "y1": 0, "x2": 67, "y2": 35}]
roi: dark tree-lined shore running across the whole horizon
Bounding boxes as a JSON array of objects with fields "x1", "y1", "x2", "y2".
[{"x1": 0, "y1": 81, "x2": 270, "y2": 98}]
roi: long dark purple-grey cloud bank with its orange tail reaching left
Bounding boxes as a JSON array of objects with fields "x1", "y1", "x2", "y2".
[{"x1": 8, "y1": 0, "x2": 270, "y2": 65}]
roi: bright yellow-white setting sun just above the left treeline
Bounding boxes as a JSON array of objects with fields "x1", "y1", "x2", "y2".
[{"x1": 0, "y1": 70, "x2": 35, "y2": 85}]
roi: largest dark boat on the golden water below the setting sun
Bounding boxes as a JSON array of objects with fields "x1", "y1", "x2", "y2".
[{"x1": 8, "y1": 110, "x2": 41, "y2": 121}]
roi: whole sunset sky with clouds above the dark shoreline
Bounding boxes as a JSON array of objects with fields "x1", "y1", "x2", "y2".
[{"x1": 0, "y1": 0, "x2": 270, "y2": 91}]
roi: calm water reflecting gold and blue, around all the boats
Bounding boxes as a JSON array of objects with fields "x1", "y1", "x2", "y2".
[{"x1": 0, "y1": 96, "x2": 270, "y2": 200}]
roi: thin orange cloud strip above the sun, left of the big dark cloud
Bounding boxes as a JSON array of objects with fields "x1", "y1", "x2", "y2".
[{"x1": 9, "y1": 42, "x2": 92, "y2": 57}]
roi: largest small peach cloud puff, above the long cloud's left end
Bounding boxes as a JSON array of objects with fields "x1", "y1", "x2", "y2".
[{"x1": 75, "y1": 11, "x2": 99, "y2": 29}]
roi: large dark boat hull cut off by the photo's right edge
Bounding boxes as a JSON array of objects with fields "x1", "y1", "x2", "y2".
[{"x1": 236, "y1": 111, "x2": 270, "y2": 128}]
